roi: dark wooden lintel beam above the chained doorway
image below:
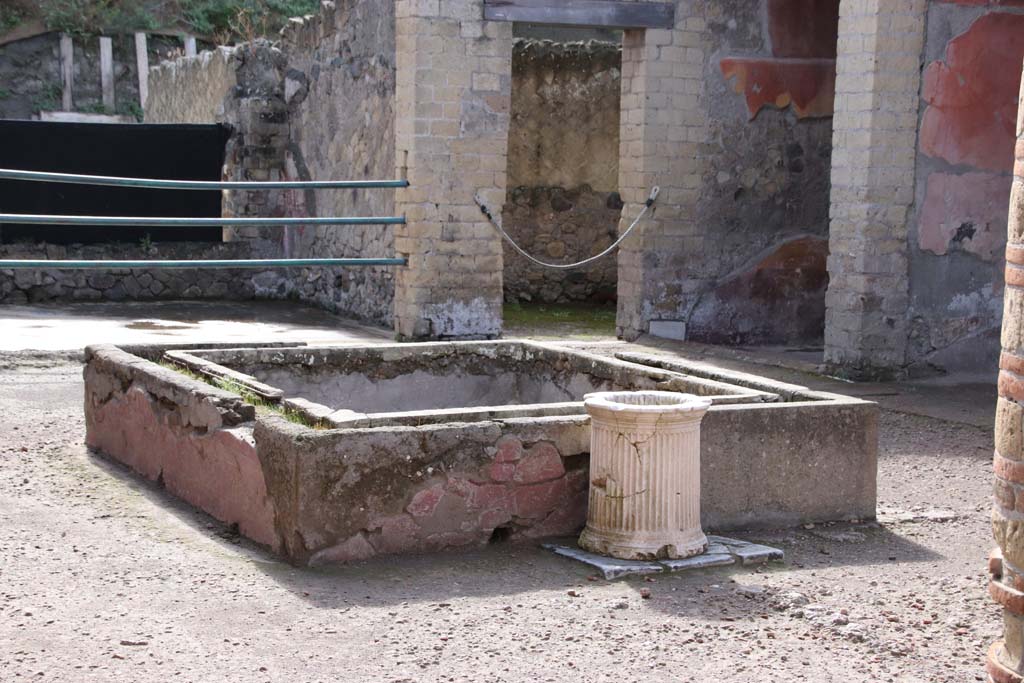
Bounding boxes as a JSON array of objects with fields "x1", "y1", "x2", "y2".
[{"x1": 483, "y1": 0, "x2": 676, "y2": 29}]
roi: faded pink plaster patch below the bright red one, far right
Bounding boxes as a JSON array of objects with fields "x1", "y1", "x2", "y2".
[{"x1": 918, "y1": 173, "x2": 1011, "y2": 261}]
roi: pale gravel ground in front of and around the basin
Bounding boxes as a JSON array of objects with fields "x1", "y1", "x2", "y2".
[{"x1": 0, "y1": 359, "x2": 1000, "y2": 683}]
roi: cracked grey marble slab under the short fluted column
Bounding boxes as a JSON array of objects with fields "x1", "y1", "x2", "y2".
[{"x1": 541, "y1": 535, "x2": 784, "y2": 581}]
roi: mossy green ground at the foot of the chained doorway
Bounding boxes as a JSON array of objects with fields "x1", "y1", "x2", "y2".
[{"x1": 504, "y1": 303, "x2": 615, "y2": 340}]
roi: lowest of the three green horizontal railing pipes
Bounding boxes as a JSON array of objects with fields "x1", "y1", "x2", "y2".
[{"x1": 0, "y1": 258, "x2": 407, "y2": 270}]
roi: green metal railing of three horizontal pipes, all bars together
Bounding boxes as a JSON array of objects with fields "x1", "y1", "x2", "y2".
[{"x1": 0, "y1": 169, "x2": 409, "y2": 270}]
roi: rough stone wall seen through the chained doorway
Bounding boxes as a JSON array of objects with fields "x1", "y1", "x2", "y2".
[{"x1": 502, "y1": 40, "x2": 622, "y2": 302}]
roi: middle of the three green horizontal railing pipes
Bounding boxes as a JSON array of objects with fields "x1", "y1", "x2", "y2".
[{"x1": 0, "y1": 213, "x2": 406, "y2": 227}]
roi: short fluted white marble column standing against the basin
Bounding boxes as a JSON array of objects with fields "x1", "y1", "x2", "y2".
[{"x1": 580, "y1": 391, "x2": 711, "y2": 559}]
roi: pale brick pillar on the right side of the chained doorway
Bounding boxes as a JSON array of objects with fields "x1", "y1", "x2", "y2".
[{"x1": 616, "y1": 9, "x2": 710, "y2": 340}]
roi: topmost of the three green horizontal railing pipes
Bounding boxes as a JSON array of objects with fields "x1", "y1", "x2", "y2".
[{"x1": 0, "y1": 168, "x2": 409, "y2": 190}]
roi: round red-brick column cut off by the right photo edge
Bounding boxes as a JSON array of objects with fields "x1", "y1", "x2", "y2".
[{"x1": 988, "y1": 65, "x2": 1024, "y2": 683}]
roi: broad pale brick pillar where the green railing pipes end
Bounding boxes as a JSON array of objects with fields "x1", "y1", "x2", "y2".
[{"x1": 394, "y1": 0, "x2": 512, "y2": 339}]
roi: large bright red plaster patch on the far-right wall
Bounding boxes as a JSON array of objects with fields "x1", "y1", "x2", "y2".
[{"x1": 921, "y1": 13, "x2": 1024, "y2": 172}]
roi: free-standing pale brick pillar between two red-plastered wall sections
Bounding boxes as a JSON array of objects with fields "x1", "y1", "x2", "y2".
[{"x1": 824, "y1": 0, "x2": 927, "y2": 379}]
